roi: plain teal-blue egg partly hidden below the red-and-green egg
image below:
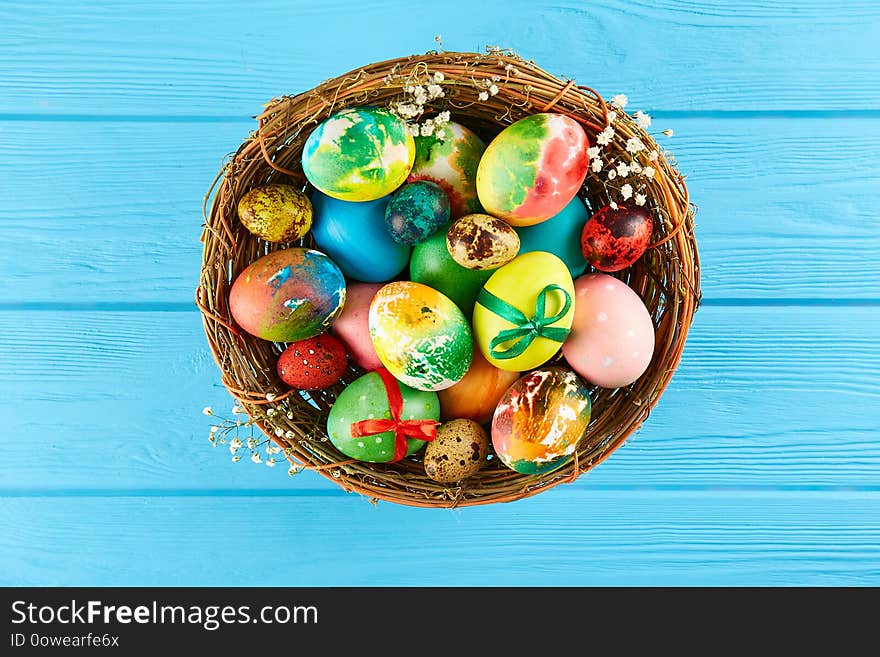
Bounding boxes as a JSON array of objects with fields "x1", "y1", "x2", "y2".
[{"x1": 516, "y1": 196, "x2": 590, "y2": 278}]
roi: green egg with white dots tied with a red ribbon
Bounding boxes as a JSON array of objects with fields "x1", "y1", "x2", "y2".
[{"x1": 327, "y1": 372, "x2": 440, "y2": 463}]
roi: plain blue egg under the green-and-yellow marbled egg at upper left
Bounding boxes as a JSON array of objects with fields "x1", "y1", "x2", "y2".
[{"x1": 312, "y1": 192, "x2": 411, "y2": 283}]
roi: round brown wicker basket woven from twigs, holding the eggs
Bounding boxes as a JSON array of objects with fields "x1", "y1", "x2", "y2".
[{"x1": 196, "y1": 50, "x2": 700, "y2": 507}]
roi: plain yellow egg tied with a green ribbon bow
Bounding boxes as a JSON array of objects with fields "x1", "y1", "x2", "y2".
[{"x1": 474, "y1": 251, "x2": 574, "y2": 372}]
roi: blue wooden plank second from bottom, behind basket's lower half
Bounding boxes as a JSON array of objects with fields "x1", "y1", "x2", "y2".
[{"x1": 0, "y1": 307, "x2": 880, "y2": 494}]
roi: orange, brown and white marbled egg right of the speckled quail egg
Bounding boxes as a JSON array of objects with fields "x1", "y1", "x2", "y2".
[{"x1": 492, "y1": 367, "x2": 591, "y2": 474}]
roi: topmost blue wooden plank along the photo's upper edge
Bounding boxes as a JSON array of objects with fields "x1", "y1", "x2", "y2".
[{"x1": 0, "y1": 0, "x2": 880, "y2": 117}]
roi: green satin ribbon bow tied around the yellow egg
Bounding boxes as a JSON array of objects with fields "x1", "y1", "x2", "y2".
[{"x1": 477, "y1": 285, "x2": 571, "y2": 360}]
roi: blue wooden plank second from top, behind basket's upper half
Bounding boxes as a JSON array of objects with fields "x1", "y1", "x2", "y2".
[{"x1": 0, "y1": 118, "x2": 880, "y2": 304}]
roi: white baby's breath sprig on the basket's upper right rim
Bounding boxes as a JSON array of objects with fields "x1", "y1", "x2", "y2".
[{"x1": 587, "y1": 94, "x2": 673, "y2": 210}]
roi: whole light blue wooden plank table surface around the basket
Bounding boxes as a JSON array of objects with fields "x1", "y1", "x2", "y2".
[{"x1": 0, "y1": 0, "x2": 880, "y2": 585}]
